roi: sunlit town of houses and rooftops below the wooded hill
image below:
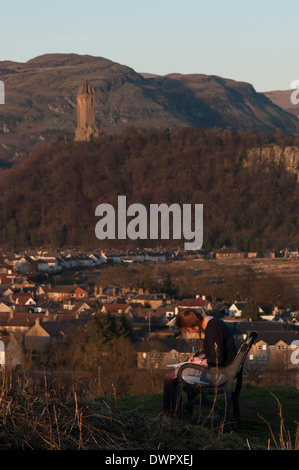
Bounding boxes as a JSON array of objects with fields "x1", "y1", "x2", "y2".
[{"x1": 0, "y1": 247, "x2": 299, "y2": 387}]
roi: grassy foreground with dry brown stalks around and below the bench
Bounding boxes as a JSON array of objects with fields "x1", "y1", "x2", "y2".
[{"x1": 0, "y1": 374, "x2": 299, "y2": 450}]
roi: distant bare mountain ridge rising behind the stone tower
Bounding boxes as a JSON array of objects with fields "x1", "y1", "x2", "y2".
[{"x1": 0, "y1": 54, "x2": 299, "y2": 162}]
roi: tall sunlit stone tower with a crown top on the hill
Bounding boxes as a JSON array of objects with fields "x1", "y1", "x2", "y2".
[{"x1": 75, "y1": 80, "x2": 101, "y2": 141}]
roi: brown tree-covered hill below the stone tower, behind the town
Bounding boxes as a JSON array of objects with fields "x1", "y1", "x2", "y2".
[{"x1": 0, "y1": 127, "x2": 299, "y2": 251}]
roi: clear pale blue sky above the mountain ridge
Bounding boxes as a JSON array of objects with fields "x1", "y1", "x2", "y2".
[{"x1": 0, "y1": 0, "x2": 299, "y2": 91}]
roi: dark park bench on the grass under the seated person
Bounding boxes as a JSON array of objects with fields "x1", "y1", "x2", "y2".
[{"x1": 176, "y1": 332, "x2": 257, "y2": 424}]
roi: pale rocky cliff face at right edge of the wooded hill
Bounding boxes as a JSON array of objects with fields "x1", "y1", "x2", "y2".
[{"x1": 246, "y1": 145, "x2": 299, "y2": 181}]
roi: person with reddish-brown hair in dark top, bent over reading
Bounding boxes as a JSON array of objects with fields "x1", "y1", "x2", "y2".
[{"x1": 163, "y1": 309, "x2": 237, "y2": 416}]
